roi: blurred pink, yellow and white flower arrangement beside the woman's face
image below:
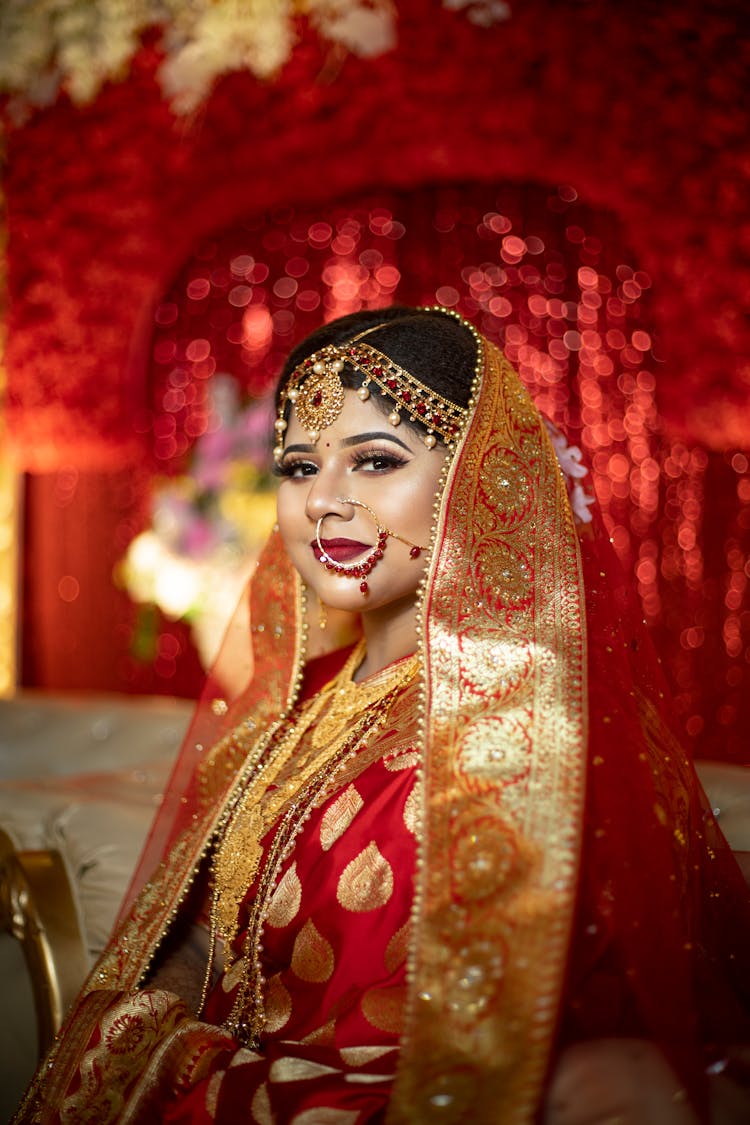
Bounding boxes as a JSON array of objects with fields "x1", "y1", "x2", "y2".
[{"x1": 118, "y1": 375, "x2": 275, "y2": 666}]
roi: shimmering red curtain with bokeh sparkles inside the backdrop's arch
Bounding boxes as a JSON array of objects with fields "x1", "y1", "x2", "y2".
[{"x1": 143, "y1": 185, "x2": 750, "y2": 756}]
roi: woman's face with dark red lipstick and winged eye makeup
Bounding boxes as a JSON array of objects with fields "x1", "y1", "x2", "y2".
[{"x1": 278, "y1": 390, "x2": 445, "y2": 612}]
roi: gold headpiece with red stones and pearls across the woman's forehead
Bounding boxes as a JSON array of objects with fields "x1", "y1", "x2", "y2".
[{"x1": 273, "y1": 322, "x2": 469, "y2": 461}]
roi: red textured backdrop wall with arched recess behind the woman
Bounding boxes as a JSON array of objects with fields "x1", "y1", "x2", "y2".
[{"x1": 4, "y1": 0, "x2": 750, "y2": 759}]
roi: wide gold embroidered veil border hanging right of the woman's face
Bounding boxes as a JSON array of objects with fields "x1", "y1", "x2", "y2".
[{"x1": 388, "y1": 345, "x2": 586, "y2": 1125}]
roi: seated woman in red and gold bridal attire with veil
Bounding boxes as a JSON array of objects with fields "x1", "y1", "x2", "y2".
[{"x1": 18, "y1": 307, "x2": 750, "y2": 1125}]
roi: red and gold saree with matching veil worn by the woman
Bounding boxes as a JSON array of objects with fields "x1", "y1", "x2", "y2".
[{"x1": 13, "y1": 328, "x2": 750, "y2": 1125}]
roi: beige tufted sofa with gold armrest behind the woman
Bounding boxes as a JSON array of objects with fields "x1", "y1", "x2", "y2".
[{"x1": 0, "y1": 693, "x2": 750, "y2": 1121}]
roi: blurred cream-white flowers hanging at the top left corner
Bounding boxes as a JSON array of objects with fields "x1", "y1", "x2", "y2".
[{"x1": 0, "y1": 0, "x2": 396, "y2": 115}]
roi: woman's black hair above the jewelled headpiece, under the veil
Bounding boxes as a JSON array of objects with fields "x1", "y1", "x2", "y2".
[{"x1": 277, "y1": 305, "x2": 477, "y2": 430}]
